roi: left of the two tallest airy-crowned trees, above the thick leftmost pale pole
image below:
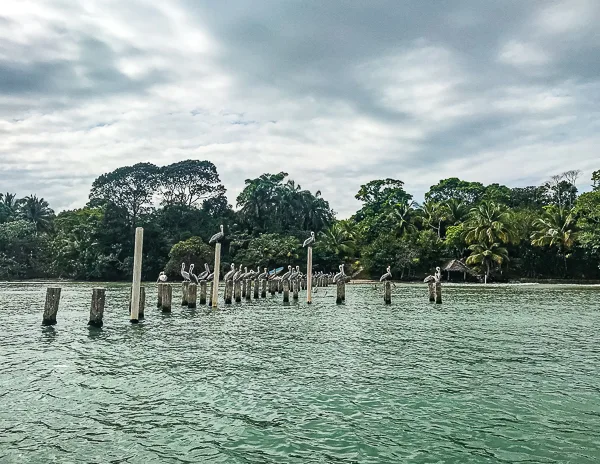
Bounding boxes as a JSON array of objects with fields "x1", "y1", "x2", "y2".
[{"x1": 90, "y1": 163, "x2": 160, "y2": 228}]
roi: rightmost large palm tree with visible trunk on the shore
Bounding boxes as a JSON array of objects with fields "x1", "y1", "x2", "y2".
[{"x1": 531, "y1": 206, "x2": 577, "y2": 275}]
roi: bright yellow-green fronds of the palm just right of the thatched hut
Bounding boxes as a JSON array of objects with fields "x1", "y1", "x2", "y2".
[{"x1": 465, "y1": 201, "x2": 514, "y2": 244}]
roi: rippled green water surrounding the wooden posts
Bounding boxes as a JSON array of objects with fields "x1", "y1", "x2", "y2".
[{"x1": 0, "y1": 284, "x2": 600, "y2": 463}]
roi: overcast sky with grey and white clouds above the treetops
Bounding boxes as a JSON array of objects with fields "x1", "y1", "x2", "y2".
[{"x1": 0, "y1": 0, "x2": 600, "y2": 217}]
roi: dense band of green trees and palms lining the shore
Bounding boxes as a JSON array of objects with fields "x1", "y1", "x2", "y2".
[{"x1": 0, "y1": 160, "x2": 600, "y2": 280}]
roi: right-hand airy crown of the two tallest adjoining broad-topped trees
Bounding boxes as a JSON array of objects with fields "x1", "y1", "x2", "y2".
[{"x1": 160, "y1": 160, "x2": 226, "y2": 206}]
